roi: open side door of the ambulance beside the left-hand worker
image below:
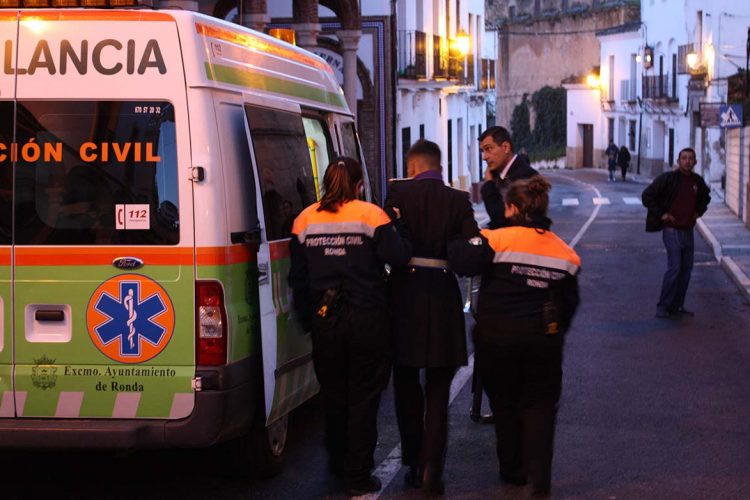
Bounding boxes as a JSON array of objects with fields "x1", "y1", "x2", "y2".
[{"x1": 245, "y1": 94, "x2": 328, "y2": 424}]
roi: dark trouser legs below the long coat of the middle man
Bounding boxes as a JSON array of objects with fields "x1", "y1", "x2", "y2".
[{"x1": 393, "y1": 366, "x2": 456, "y2": 480}]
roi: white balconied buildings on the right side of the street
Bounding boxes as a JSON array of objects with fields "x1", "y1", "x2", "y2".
[{"x1": 568, "y1": 0, "x2": 750, "y2": 190}]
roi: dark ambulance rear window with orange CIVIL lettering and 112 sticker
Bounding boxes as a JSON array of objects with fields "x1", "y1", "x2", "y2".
[{"x1": 11, "y1": 101, "x2": 179, "y2": 245}]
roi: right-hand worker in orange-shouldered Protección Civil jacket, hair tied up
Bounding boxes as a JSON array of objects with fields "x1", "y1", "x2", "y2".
[{"x1": 448, "y1": 176, "x2": 581, "y2": 496}]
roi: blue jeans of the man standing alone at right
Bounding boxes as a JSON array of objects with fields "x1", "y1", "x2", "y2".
[{"x1": 656, "y1": 227, "x2": 695, "y2": 312}]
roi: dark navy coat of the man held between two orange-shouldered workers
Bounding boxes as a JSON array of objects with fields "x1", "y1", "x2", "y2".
[{"x1": 385, "y1": 172, "x2": 479, "y2": 368}]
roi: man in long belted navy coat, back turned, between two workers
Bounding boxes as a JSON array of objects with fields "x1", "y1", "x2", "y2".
[{"x1": 385, "y1": 140, "x2": 479, "y2": 494}]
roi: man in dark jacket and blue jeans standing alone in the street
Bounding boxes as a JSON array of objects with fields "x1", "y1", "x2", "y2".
[{"x1": 641, "y1": 148, "x2": 711, "y2": 318}]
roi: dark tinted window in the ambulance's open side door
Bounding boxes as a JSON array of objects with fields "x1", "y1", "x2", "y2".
[{"x1": 245, "y1": 105, "x2": 315, "y2": 241}]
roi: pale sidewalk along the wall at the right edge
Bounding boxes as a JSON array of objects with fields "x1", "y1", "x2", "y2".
[{"x1": 697, "y1": 195, "x2": 750, "y2": 301}]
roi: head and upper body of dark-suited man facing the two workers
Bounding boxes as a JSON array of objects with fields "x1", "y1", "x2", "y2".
[{"x1": 479, "y1": 126, "x2": 538, "y2": 229}]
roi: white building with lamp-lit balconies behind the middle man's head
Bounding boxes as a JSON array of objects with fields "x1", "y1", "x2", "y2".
[{"x1": 396, "y1": 0, "x2": 496, "y2": 190}]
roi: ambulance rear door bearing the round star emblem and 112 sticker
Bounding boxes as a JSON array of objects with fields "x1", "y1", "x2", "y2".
[{"x1": 10, "y1": 10, "x2": 195, "y2": 419}]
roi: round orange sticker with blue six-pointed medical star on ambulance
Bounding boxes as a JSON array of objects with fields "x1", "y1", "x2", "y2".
[{"x1": 86, "y1": 274, "x2": 174, "y2": 363}]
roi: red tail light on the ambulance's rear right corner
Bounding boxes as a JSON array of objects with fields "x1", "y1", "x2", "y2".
[{"x1": 195, "y1": 281, "x2": 227, "y2": 366}]
